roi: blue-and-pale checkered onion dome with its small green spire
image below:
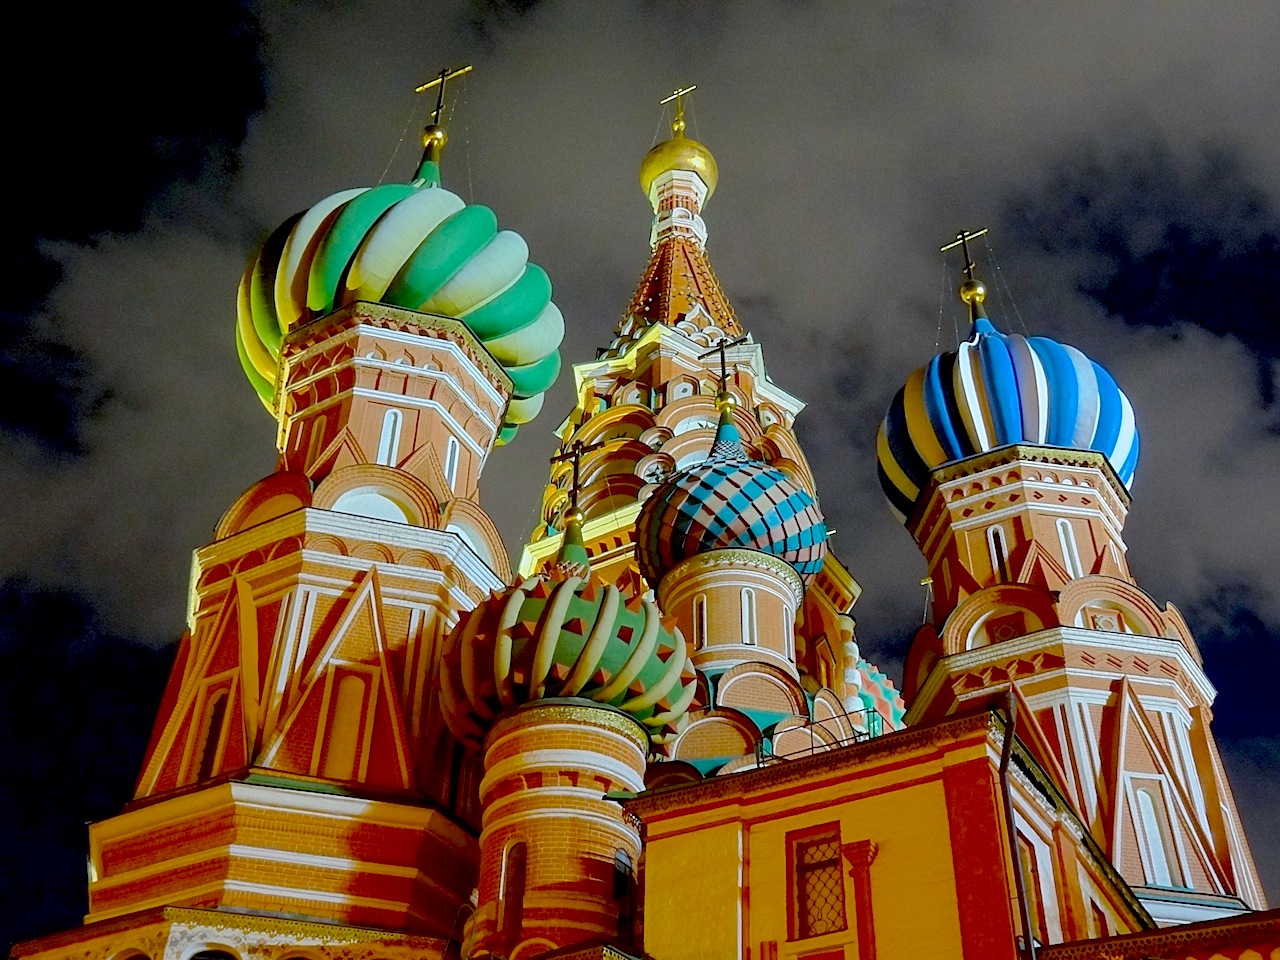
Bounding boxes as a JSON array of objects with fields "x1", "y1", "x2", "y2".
[{"x1": 636, "y1": 392, "x2": 827, "y2": 585}]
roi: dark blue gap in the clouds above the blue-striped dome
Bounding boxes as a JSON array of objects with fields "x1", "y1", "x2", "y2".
[{"x1": 1005, "y1": 143, "x2": 1280, "y2": 394}]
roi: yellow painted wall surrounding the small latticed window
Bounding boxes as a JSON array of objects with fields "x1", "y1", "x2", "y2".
[{"x1": 645, "y1": 768, "x2": 960, "y2": 960}]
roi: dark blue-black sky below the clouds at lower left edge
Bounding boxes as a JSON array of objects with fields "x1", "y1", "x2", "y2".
[{"x1": 0, "y1": 580, "x2": 172, "y2": 950}]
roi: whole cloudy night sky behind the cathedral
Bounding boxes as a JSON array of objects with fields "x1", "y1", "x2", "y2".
[{"x1": 0, "y1": 0, "x2": 1280, "y2": 945}]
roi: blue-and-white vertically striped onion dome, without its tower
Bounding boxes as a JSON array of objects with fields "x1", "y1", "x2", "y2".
[{"x1": 876, "y1": 316, "x2": 1138, "y2": 522}]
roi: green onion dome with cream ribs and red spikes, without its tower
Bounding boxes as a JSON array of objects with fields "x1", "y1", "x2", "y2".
[{"x1": 440, "y1": 512, "x2": 698, "y2": 748}]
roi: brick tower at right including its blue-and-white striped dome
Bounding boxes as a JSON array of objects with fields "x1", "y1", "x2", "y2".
[{"x1": 878, "y1": 245, "x2": 1265, "y2": 923}]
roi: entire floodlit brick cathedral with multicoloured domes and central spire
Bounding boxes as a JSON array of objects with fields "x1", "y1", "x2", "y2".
[{"x1": 12, "y1": 79, "x2": 1280, "y2": 960}]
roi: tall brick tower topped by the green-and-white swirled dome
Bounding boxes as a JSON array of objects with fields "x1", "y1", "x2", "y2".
[{"x1": 27, "y1": 96, "x2": 563, "y2": 957}]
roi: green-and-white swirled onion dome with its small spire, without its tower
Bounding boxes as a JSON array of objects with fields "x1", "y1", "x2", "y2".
[{"x1": 236, "y1": 127, "x2": 564, "y2": 443}]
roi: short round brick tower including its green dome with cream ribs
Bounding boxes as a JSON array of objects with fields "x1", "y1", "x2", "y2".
[{"x1": 440, "y1": 511, "x2": 696, "y2": 960}]
